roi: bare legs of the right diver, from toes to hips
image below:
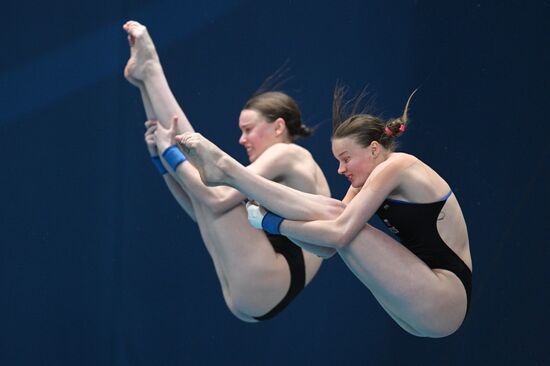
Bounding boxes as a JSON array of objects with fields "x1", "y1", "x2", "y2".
[{"x1": 178, "y1": 134, "x2": 466, "y2": 337}]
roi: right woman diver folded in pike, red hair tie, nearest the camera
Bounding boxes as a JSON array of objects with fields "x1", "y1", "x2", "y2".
[{"x1": 176, "y1": 88, "x2": 472, "y2": 337}]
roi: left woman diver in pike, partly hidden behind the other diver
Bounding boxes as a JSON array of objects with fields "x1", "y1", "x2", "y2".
[{"x1": 123, "y1": 21, "x2": 334, "y2": 322}]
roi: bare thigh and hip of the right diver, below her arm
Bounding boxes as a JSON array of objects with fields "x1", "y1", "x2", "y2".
[{"x1": 338, "y1": 225, "x2": 466, "y2": 337}]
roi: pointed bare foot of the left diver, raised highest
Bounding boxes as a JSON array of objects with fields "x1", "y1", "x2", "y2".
[{"x1": 122, "y1": 20, "x2": 160, "y2": 86}]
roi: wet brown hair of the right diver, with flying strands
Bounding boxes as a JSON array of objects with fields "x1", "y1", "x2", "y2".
[{"x1": 331, "y1": 84, "x2": 416, "y2": 151}]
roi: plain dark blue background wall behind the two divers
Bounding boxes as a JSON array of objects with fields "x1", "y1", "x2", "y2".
[{"x1": 0, "y1": 0, "x2": 550, "y2": 366}]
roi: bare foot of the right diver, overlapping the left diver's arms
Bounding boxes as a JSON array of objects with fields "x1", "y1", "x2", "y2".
[{"x1": 176, "y1": 132, "x2": 232, "y2": 186}]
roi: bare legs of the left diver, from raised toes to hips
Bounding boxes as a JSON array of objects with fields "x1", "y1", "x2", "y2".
[{"x1": 125, "y1": 22, "x2": 321, "y2": 321}]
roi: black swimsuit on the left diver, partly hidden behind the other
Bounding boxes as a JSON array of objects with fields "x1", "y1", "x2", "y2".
[{"x1": 254, "y1": 233, "x2": 306, "y2": 320}]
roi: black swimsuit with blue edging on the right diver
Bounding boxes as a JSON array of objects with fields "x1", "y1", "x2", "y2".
[{"x1": 376, "y1": 192, "x2": 472, "y2": 309}]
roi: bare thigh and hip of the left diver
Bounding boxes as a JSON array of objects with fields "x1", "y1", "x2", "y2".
[{"x1": 181, "y1": 179, "x2": 321, "y2": 322}]
